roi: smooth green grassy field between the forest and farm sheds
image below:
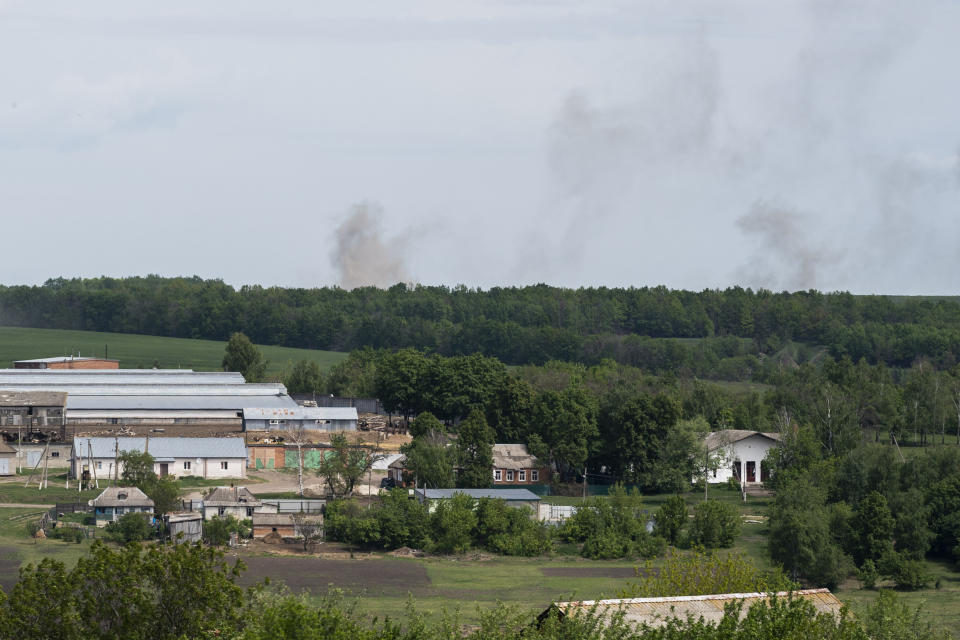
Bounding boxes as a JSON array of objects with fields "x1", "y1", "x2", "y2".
[{"x1": 0, "y1": 327, "x2": 347, "y2": 375}]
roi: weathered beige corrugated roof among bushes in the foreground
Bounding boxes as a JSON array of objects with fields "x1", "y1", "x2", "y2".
[{"x1": 537, "y1": 589, "x2": 843, "y2": 627}]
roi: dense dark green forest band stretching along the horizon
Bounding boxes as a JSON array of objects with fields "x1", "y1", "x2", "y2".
[{"x1": 0, "y1": 276, "x2": 960, "y2": 379}]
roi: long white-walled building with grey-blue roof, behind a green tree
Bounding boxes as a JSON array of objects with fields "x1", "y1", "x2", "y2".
[{"x1": 71, "y1": 438, "x2": 247, "y2": 478}]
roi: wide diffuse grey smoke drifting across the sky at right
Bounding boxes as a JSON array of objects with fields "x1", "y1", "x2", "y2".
[{"x1": 523, "y1": 2, "x2": 960, "y2": 292}]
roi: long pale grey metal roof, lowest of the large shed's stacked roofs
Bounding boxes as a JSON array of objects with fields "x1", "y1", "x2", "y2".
[{"x1": 67, "y1": 394, "x2": 297, "y2": 410}]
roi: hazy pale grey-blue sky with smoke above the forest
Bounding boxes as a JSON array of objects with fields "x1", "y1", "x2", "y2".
[{"x1": 0, "y1": 0, "x2": 960, "y2": 294}]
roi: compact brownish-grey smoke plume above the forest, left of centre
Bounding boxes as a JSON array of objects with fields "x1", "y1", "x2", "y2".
[{"x1": 331, "y1": 202, "x2": 409, "y2": 289}]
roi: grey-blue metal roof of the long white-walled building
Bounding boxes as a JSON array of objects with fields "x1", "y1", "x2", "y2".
[{"x1": 73, "y1": 437, "x2": 247, "y2": 459}]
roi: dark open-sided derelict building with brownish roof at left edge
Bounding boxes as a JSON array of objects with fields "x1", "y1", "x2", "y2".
[{"x1": 0, "y1": 388, "x2": 67, "y2": 442}]
